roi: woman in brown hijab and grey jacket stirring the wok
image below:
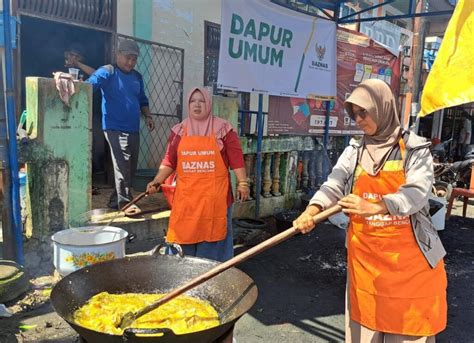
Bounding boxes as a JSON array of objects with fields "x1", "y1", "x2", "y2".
[{"x1": 294, "y1": 79, "x2": 447, "y2": 343}]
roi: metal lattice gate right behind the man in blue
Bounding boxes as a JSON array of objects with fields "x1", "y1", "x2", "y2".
[{"x1": 115, "y1": 35, "x2": 184, "y2": 169}]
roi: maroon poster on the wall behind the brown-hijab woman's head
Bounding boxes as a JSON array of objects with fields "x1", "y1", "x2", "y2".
[{"x1": 268, "y1": 29, "x2": 400, "y2": 136}]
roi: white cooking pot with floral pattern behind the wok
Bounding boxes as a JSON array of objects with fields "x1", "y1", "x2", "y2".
[{"x1": 51, "y1": 226, "x2": 134, "y2": 276}]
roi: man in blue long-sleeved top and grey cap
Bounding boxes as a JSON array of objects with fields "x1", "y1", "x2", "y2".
[{"x1": 86, "y1": 40, "x2": 155, "y2": 214}]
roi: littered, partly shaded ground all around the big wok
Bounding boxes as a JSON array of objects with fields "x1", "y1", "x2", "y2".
[{"x1": 0, "y1": 204, "x2": 474, "y2": 343}]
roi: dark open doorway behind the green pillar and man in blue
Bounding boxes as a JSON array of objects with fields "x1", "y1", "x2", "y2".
[{"x1": 19, "y1": 15, "x2": 112, "y2": 183}]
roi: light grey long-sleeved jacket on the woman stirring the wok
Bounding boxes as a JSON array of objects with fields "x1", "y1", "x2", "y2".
[{"x1": 309, "y1": 132, "x2": 446, "y2": 268}]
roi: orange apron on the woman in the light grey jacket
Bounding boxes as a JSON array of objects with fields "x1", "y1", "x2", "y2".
[{"x1": 347, "y1": 139, "x2": 447, "y2": 336}]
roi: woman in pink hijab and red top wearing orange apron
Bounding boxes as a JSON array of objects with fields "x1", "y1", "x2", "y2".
[{"x1": 147, "y1": 88, "x2": 249, "y2": 261}]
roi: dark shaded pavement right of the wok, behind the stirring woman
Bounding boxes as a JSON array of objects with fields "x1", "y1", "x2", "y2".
[{"x1": 237, "y1": 212, "x2": 474, "y2": 343}]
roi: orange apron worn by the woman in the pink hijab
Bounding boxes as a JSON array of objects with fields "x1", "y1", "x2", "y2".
[{"x1": 166, "y1": 128, "x2": 229, "y2": 244}]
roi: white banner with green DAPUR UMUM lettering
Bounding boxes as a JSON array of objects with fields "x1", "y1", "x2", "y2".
[{"x1": 217, "y1": 0, "x2": 336, "y2": 98}]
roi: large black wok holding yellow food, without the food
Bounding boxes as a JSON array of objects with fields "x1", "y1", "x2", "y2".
[{"x1": 51, "y1": 255, "x2": 258, "y2": 343}]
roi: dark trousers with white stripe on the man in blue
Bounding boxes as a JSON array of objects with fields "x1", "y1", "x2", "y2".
[{"x1": 104, "y1": 130, "x2": 140, "y2": 208}]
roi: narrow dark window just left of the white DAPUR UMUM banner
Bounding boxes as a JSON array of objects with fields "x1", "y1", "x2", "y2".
[{"x1": 204, "y1": 21, "x2": 221, "y2": 87}]
